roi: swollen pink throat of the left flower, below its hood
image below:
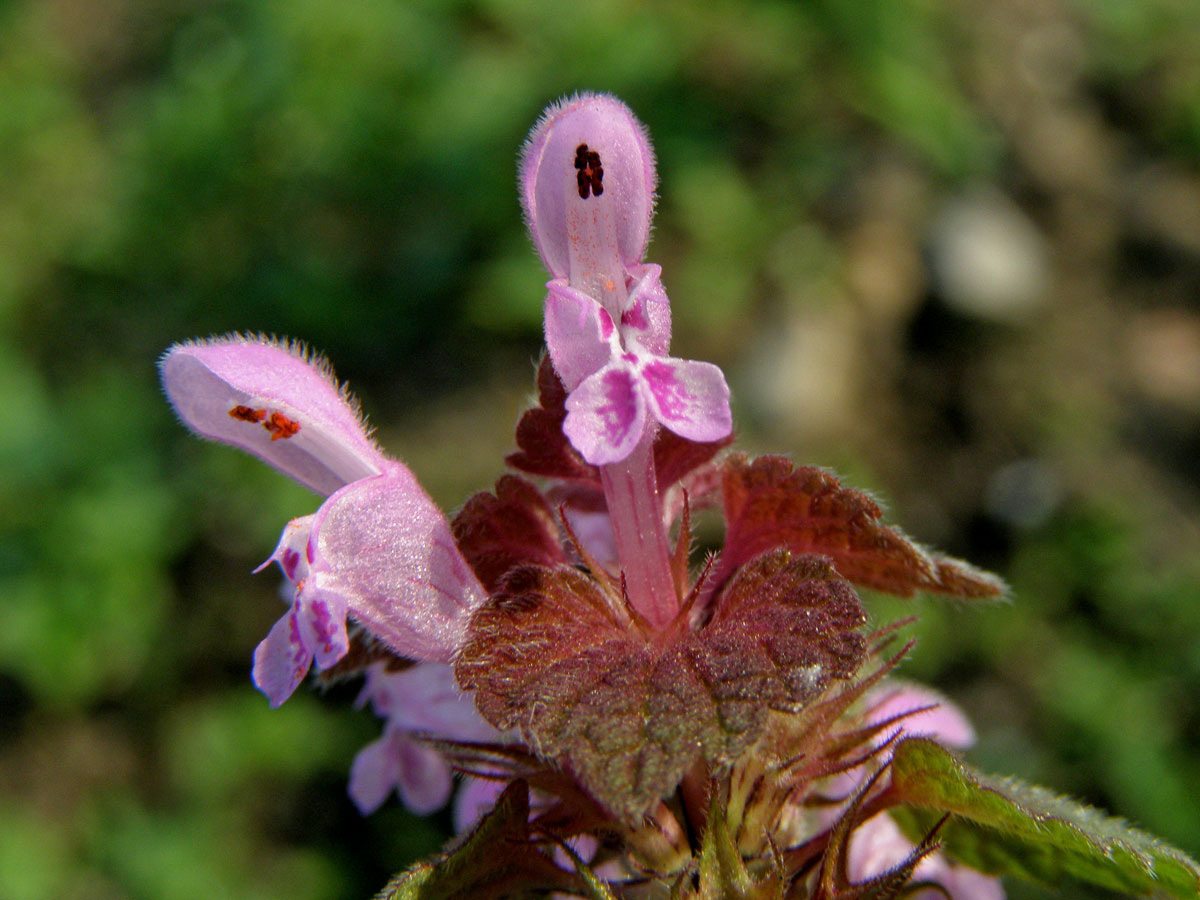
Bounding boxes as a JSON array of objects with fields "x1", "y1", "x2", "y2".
[{"x1": 310, "y1": 463, "x2": 486, "y2": 662}]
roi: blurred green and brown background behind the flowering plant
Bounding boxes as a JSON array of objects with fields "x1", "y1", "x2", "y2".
[{"x1": 0, "y1": 0, "x2": 1200, "y2": 900}]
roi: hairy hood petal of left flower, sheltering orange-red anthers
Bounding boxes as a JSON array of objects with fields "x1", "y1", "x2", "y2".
[{"x1": 160, "y1": 337, "x2": 384, "y2": 496}]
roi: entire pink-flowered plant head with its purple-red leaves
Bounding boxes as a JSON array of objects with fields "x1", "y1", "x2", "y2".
[{"x1": 161, "y1": 95, "x2": 1190, "y2": 900}]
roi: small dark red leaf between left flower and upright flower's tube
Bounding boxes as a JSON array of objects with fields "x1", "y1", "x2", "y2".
[{"x1": 451, "y1": 475, "x2": 566, "y2": 594}]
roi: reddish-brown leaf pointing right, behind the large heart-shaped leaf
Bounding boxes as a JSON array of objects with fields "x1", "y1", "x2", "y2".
[{"x1": 712, "y1": 455, "x2": 1004, "y2": 598}]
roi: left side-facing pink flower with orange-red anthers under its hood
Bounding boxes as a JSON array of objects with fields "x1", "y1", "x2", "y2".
[{"x1": 160, "y1": 336, "x2": 486, "y2": 706}]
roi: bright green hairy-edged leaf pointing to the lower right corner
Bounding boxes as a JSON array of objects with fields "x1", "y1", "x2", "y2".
[{"x1": 892, "y1": 738, "x2": 1200, "y2": 900}]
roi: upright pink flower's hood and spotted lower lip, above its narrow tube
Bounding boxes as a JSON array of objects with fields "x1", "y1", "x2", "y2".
[{"x1": 521, "y1": 94, "x2": 733, "y2": 466}]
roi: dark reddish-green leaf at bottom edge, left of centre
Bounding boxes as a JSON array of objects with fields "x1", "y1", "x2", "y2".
[{"x1": 376, "y1": 781, "x2": 578, "y2": 900}]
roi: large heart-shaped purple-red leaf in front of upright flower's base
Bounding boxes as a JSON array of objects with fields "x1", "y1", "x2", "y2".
[{"x1": 455, "y1": 551, "x2": 866, "y2": 821}]
